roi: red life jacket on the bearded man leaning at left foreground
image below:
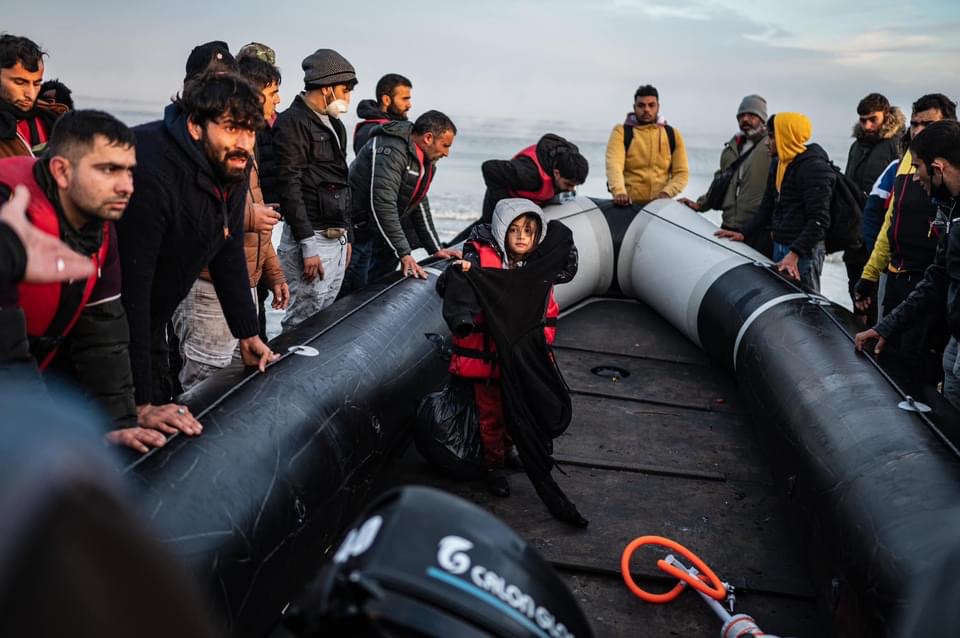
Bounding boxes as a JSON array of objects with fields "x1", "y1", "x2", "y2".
[{"x1": 0, "y1": 157, "x2": 110, "y2": 370}]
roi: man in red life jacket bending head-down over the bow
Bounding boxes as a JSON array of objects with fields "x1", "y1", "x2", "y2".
[{"x1": 480, "y1": 133, "x2": 590, "y2": 224}]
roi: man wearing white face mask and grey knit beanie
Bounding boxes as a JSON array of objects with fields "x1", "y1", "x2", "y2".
[{"x1": 273, "y1": 49, "x2": 357, "y2": 330}]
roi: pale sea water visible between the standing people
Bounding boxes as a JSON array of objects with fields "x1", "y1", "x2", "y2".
[{"x1": 103, "y1": 99, "x2": 851, "y2": 337}]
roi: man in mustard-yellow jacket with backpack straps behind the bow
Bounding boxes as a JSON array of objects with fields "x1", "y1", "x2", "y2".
[{"x1": 606, "y1": 85, "x2": 690, "y2": 206}]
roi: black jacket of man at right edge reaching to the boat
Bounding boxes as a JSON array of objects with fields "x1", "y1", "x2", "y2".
[{"x1": 876, "y1": 199, "x2": 960, "y2": 340}]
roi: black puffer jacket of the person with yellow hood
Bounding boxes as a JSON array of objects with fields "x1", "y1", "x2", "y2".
[{"x1": 743, "y1": 144, "x2": 837, "y2": 257}]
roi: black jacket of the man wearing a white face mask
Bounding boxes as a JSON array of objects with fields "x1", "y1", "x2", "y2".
[{"x1": 273, "y1": 95, "x2": 350, "y2": 241}]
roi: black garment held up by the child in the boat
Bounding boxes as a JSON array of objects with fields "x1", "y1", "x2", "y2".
[{"x1": 443, "y1": 221, "x2": 588, "y2": 527}]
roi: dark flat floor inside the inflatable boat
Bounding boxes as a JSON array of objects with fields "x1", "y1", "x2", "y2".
[{"x1": 385, "y1": 298, "x2": 829, "y2": 638}]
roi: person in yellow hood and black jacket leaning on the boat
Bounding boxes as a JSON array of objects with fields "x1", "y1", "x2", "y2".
[{"x1": 716, "y1": 113, "x2": 837, "y2": 292}]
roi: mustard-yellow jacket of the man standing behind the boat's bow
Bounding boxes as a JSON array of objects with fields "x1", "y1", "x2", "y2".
[{"x1": 606, "y1": 124, "x2": 690, "y2": 203}]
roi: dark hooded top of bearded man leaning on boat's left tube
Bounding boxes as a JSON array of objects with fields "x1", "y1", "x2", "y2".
[{"x1": 117, "y1": 104, "x2": 258, "y2": 405}]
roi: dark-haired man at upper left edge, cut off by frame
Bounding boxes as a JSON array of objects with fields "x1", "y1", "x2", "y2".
[{"x1": 0, "y1": 34, "x2": 67, "y2": 157}]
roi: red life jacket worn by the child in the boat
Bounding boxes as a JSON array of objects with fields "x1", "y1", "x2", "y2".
[{"x1": 448, "y1": 241, "x2": 560, "y2": 379}]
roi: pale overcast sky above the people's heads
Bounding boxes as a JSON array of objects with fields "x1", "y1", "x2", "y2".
[{"x1": 3, "y1": 0, "x2": 960, "y2": 144}]
